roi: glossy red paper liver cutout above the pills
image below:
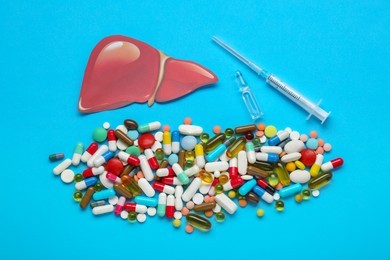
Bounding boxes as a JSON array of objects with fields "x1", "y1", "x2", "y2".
[{"x1": 78, "y1": 36, "x2": 218, "y2": 113}]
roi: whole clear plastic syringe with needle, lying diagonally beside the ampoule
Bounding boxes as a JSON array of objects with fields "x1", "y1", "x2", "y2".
[{"x1": 212, "y1": 36, "x2": 331, "y2": 124}]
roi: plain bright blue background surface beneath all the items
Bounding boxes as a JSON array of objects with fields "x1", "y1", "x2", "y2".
[{"x1": 0, "y1": 0, "x2": 390, "y2": 259}]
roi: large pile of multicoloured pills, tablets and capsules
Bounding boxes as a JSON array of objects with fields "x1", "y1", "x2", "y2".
[{"x1": 49, "y1": 118, "x2": 343, "y2": 233}]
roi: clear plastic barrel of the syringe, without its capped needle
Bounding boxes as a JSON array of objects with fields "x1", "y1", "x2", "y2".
[{"x1": 267, "y1": 74, "x2": 330, "y2": 123}]
